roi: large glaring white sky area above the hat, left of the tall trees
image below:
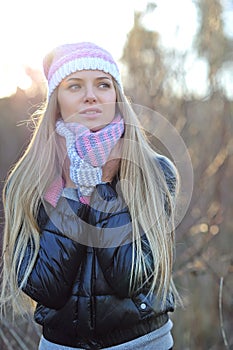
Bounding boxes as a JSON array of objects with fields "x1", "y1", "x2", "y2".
[{"x1": 0, "y1": 0, "x2": 134, "y2": 98}]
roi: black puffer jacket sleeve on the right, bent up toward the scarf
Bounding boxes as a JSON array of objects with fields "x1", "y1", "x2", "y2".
[{"x1": 91, "y1": 156, "x2": 176, "y2": 297}]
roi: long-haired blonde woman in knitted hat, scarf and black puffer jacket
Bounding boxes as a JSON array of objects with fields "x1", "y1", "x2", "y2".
[{"x1": 1, "y1": 43, "x2": 178, "y2": 350}]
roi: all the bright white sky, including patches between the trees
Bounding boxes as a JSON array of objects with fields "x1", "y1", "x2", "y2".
[{"x1": 0, "y1": 0, "x2": 232, "y2": 98}]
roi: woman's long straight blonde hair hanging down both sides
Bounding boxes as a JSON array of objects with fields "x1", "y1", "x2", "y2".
[{"x1": 0, "y1": 83, "x2": 178, "y2": 313}]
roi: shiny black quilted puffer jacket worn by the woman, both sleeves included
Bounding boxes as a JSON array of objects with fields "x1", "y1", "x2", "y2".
[{"x1": 19, "y1": 157, "x2": 175, "y2": 349}]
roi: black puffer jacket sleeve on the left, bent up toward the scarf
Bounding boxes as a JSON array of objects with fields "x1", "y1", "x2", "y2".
[{"x1": 18, "y1": 197, "x2": 86, "y2": 309}]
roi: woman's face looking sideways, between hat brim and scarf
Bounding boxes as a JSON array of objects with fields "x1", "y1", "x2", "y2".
[{"x1": 58, "y1": 70, "x2": 116, "y2": 130}]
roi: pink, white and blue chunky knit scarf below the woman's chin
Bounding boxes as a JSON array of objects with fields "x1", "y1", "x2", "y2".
[{"x1": 56, "y1": 115, "x2": 124, "y2": 200}]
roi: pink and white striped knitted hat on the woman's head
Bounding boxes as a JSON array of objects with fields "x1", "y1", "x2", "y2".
[{"x1": 43, "y1": 42, "x2": 123, "y2": 97}]
